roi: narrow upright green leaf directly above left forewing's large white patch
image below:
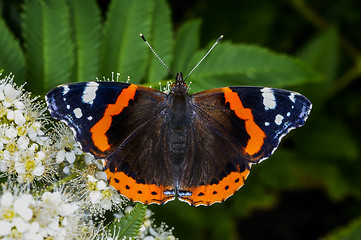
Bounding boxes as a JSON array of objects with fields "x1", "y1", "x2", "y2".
[{"x1": 68, "y1": 0, "x2": 102, "y2": 82}]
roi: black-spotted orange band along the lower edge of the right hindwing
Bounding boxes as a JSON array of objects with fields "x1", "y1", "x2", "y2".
[{"x1": 179, "y1": 164, "x2": 251, "y2": 206}]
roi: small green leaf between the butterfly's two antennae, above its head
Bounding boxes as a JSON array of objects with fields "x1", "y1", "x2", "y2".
[{"x1": 172, "y1": 20, "x2": 201, "y2": 74}]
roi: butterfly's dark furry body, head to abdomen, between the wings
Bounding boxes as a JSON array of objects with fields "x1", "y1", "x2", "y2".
[{"x1": 167, "y1": 73, "x2": 192, "y2": 165}]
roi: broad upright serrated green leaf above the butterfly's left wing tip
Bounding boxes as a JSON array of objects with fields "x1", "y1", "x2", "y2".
[{"x1": 22, "y1": 0, "x2": 74, "y2": 94}]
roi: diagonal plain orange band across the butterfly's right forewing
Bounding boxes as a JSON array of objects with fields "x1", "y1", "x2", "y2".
[{"x1": 223, "y1": 88, "x2": 266, "y2": 155}]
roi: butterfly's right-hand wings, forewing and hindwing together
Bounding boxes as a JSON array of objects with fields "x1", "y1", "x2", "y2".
[{"x1": 178, "y1": 87, "x2": 311, "y2": 206}]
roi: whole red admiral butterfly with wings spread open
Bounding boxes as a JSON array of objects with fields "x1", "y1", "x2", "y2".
[{"x1": 46, "y1": 35, "x2": 312, "y2": 206}]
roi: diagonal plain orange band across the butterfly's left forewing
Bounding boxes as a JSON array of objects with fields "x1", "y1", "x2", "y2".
[{"x1": 90, "y1": 84, "x2": 137, "y2": 151}]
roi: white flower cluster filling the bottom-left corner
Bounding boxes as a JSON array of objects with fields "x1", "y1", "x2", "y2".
[{"x1": 0, "y1": 190, "x2": 81, "y2": 240}]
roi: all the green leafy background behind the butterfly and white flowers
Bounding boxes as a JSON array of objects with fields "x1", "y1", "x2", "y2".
[{"x1": 0, "y1": 0, "x2": 361, "y2": 239}]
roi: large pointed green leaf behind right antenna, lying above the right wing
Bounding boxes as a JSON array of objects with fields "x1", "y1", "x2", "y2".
[{"x1": 186, "y1": 42, "x2": 320, "y2": 92}]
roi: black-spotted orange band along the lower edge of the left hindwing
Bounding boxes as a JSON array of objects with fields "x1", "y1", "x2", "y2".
[{"x1": 105, "y1": 169, "x2": 175, "y2": 204}]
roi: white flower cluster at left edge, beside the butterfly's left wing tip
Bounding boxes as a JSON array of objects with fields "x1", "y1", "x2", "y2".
[{"x1": 0, "y1": 75, "x2": 53, "y2": 183}]
